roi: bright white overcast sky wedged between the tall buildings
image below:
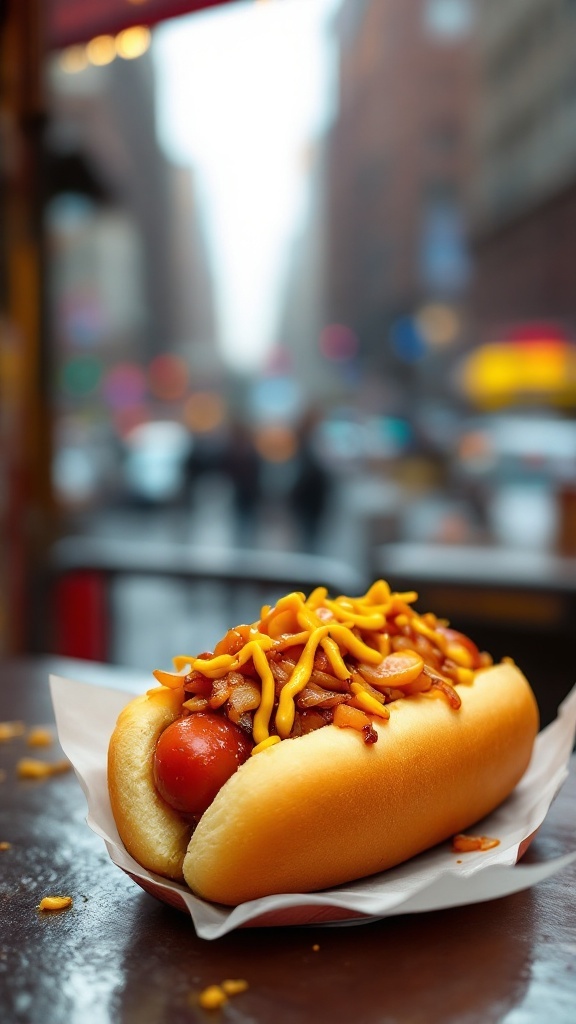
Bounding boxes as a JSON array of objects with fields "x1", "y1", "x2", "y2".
[{"x1": 154, "y1": 0, "x2": 340, "y2": 372}]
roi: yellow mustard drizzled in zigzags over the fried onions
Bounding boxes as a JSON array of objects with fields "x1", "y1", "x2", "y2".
[{"x1": 154, "y1": 580, "x2": 455, "y2": 754}]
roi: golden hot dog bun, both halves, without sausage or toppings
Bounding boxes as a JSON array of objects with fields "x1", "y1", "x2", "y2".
[{"x1": 109, "y1": 664, "x2": 538, "y2": 905}]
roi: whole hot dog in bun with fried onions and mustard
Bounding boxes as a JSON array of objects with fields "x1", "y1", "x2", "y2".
[{"x1": 108, "y1": 580, "x2": 538, "y2": 905}]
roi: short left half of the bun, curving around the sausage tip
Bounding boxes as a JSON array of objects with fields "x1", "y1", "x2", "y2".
[{"x1": 108, "y1": 686, "x2": 191, "y2": 882}]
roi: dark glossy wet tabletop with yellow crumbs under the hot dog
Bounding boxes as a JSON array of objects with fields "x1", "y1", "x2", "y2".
[{"x1": 0, "y1": 658, "x2": 576, "y2": 1024}]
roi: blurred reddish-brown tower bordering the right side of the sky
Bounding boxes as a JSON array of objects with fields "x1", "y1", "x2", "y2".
[{"x1": 328, "y1": 0, "x2": 475, "y2": 399}]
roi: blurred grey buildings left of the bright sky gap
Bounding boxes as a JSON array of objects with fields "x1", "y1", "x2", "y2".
[{"x1": 45, "y1": 40, "x2": 217, "y2": 507}]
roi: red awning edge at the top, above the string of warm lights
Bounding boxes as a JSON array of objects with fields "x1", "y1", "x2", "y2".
[{"x1": 45, "y1": 0, "x2": 234, "y2": 50}]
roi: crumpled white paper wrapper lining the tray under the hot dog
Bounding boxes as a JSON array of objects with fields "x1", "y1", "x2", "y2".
[{"x1": 50, "y1": 676, "x2": 576, "y2": 939}]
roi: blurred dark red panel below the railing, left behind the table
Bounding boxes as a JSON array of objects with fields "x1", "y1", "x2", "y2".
[{"x1": 52, "y1": 572, "x2": 109, "y2": 662}]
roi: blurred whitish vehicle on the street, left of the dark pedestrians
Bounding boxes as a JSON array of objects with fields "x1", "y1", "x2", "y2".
[{"x1": 123, "y1": 420, "x2": 194, "y2": 507}]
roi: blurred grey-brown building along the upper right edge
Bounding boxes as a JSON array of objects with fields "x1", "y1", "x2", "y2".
[{"x1": 470, "y1": 0, "x2": 576, "y2": 340}]
